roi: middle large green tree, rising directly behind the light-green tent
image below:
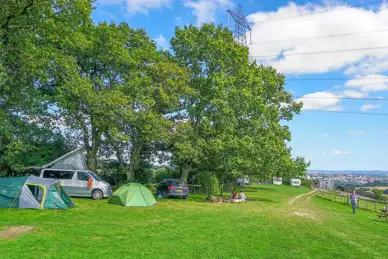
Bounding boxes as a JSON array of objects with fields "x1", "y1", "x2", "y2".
[{"x1": 53, "y1": 23, "x2": 187, "y2": 179}]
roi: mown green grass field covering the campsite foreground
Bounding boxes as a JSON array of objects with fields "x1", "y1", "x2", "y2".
[{"x1": 0, "y1": 185, "x2": 388, "y2": 259}]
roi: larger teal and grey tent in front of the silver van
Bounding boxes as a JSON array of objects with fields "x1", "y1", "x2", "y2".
[{"x1": 0, "y1": 176, "x2": 74, "y2": 209}]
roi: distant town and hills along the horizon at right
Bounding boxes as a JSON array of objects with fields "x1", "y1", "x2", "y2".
[{"x1": 307, "y1": 170, "x2": 388, "y2": 186}]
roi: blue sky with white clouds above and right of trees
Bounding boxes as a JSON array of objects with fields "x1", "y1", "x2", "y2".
[{"x1": 93, "y1": 0, "x2": 388, "y2": 170}]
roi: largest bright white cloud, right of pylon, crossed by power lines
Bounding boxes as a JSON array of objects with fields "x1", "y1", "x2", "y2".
[{"x1": 248, "y1": 1, "x2": 388, "y2": 74}]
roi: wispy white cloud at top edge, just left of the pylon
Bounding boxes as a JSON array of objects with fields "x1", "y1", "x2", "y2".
[{"x1": 183, "y1": 0, "x2": 233, "y2": 26}]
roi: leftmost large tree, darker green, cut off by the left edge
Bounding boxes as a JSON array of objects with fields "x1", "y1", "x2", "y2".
[{"x1": 0, "y1": 0, "x2": 92, "y2": 173}]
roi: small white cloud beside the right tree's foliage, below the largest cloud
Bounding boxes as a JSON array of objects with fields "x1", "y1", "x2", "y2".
[{"x1": 296, "y1": 92, "x2": 342, "y2": 111}]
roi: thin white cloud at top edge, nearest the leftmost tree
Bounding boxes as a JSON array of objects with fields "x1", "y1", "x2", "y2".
[{"x1": 98, "y1": 0, "x2": 173, "y2": 14}]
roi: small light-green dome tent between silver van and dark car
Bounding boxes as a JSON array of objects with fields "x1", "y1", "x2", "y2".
[{"x1": 109, "y1": 183, "x2": 156, "y2": 207}]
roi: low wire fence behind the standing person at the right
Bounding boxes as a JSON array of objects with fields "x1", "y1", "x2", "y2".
[{"x1": 318, "y1": 191, "x2": 388, "y2": 212}]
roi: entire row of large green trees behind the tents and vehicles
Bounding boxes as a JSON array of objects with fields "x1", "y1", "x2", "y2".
[{"x1": 0, "y1": 0, "x2": 309, "y2": 185}]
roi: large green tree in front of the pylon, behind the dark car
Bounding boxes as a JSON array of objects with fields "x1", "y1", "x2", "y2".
[{"x1": 171, "y1": 25, "x2": 301, "y2": 183}]
